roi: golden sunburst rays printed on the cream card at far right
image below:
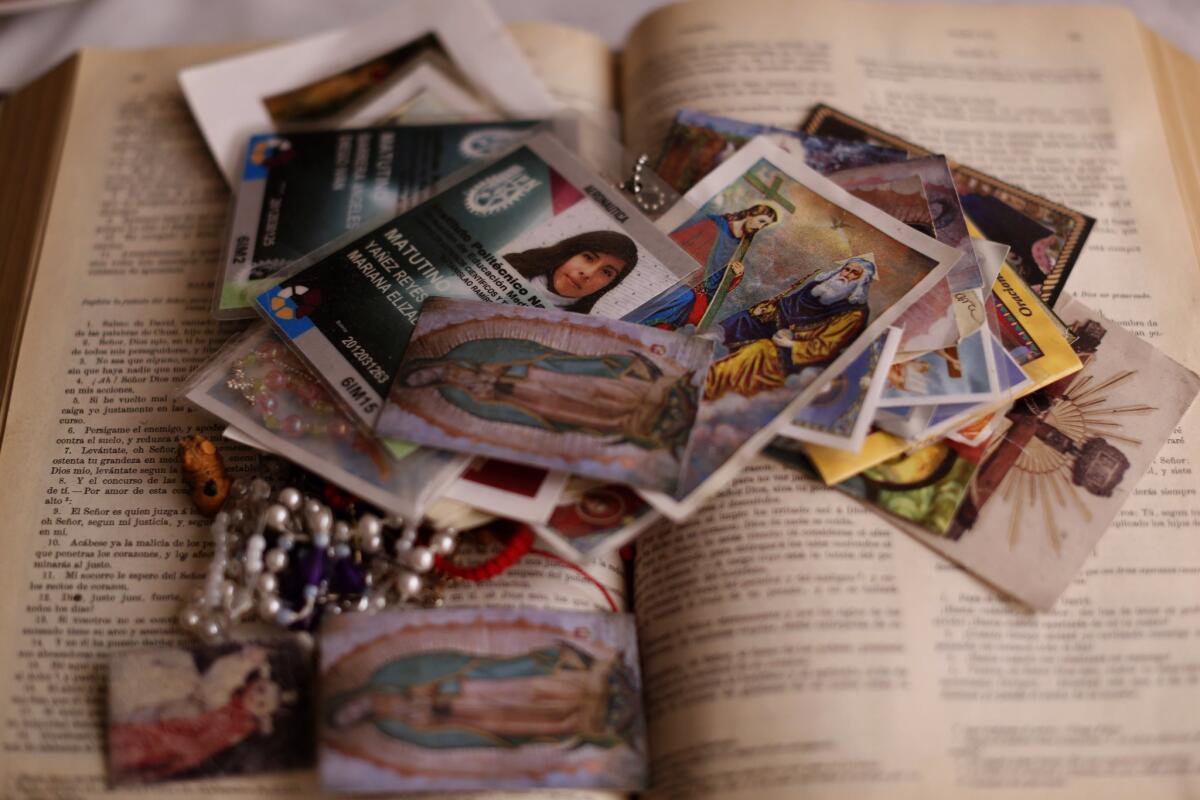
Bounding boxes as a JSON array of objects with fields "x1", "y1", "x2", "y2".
[{"x1": 988, "y1": 368, "x2": 1157, "y2": 554}]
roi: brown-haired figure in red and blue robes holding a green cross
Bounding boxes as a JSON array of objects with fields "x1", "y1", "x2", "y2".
[{"x1": 635, "y1": 203, "x2": 779, "y2": 331}]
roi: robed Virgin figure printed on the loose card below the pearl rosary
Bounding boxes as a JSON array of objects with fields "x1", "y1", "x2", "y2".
[{"x1": 326, "y1": 642, "x2": 637, "y2": 750}]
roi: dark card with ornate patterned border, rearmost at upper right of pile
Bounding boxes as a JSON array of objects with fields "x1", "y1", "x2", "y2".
[{"x1": 800, "y1": 104, "x2": 1096, "y2": 305}]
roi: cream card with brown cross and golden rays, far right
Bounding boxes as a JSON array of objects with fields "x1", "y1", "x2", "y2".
[{"x1": 905, "y1": 295, "x2": 1200, "y2": 609}]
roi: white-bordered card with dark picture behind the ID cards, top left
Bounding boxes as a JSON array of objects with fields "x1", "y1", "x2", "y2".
[{"x1": 179, "y1": 0, "x2": 559, "y2": 185}]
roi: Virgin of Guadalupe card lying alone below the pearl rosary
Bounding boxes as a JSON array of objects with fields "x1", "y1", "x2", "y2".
[{"x1": 318, "y1": 608, "x2": 647, "y2": 793}]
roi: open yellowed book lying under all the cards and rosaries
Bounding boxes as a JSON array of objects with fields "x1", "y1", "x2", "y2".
[{"x1": 0, "y1": 0, "x2": 1200, "y2": 799}]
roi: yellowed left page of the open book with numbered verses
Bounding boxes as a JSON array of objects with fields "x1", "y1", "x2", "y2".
[{"x1": 0, "y1": 48, "x2": 624, "y2": 800}]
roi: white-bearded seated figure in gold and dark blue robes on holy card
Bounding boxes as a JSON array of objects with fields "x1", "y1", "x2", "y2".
[{"x1": 704, "y1": 255, "x2": 876, "y2": 401}]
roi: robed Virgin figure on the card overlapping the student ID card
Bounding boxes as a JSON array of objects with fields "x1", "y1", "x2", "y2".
[{"x1": 392, "y1": 337, "x2": 698, "y2": 452}]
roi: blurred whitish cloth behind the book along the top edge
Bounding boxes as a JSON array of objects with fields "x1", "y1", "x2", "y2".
[{"x1": 0, "y1": 0, "x2": 1200, "y2": 92}]
